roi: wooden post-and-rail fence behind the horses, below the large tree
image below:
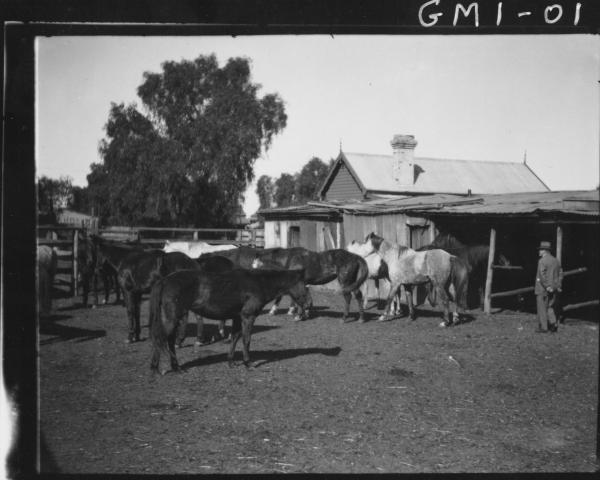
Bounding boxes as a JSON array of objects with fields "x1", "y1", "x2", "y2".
[{"x1": 37, "y1": 225, "x2": 264, "y2": 296}]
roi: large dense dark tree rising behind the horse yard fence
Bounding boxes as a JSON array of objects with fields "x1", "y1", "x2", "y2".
[{"x1": 88, "y1": 55, "x2": 287, "y2": 226}]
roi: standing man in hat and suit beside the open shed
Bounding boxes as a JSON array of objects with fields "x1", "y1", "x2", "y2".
[{"x1": 535, "y1": 242, "x2": 562, "y2": 333}]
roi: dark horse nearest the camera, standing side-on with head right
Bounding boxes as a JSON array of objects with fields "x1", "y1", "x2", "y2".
[{"x1": 150, "y1": 269, "x2": 308, "y2": 372}]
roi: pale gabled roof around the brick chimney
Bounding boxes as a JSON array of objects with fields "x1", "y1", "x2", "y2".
[{"x1": 321, "y1": 153, "x2": 550, "y2": 194}]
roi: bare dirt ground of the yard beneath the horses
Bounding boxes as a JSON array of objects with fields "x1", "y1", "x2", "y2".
[{"x1": 39, "y1": 290, "x2": 598, "y2": 474}]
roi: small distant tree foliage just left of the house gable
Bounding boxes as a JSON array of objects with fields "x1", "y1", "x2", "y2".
[{"x1": 256, "y1": 157, "x2": 334, "y2": 208}]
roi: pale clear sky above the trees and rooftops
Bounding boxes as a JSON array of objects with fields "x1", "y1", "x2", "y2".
[{"x1": 36, "y1": 35, "x2": 600, "y2": 215}]
